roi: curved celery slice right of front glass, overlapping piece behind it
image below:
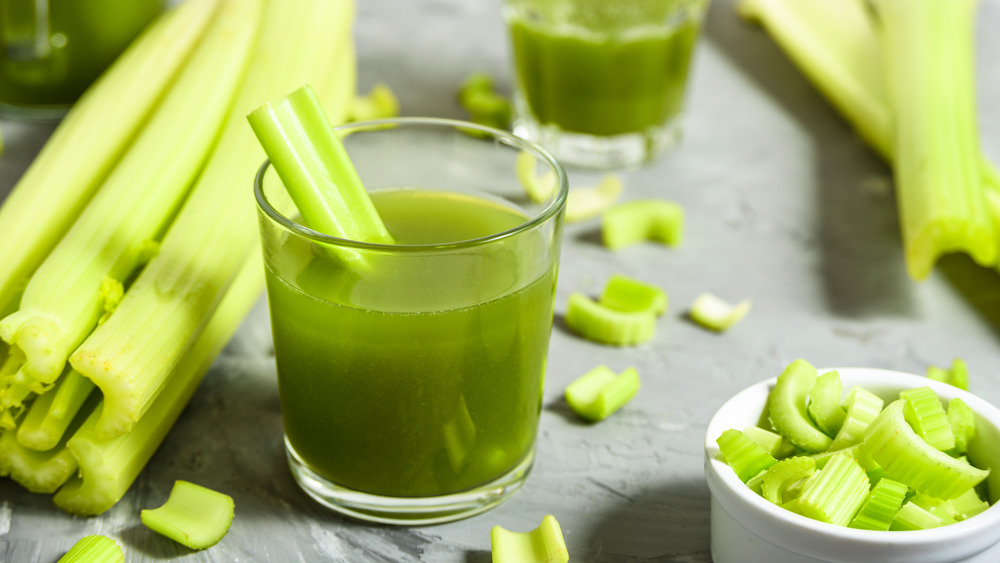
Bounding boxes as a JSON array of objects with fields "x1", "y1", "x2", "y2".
[{"x1": 566, "y1": 292, "x2": 656, "y2": 346}]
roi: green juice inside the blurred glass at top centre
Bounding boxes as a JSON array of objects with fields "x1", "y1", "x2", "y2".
[{"x1": 508, "y1": 1, "x2": 700, "y2": 136}]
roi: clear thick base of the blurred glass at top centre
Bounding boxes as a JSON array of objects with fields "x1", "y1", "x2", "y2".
[{"x1": 513, "y1": 112, "x2": 681, "y2": 170}]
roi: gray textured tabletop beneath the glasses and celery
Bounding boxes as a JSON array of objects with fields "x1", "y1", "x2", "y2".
[{"x1": 0, "y1": 0, "x2": 1000, "y2": 563}]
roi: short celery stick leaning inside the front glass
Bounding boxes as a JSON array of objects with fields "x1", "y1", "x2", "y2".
[{"x1": 247, "y1": 84, "x2": 393, "y2": 260}]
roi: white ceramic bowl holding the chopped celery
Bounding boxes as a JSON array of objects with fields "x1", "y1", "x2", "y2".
[{"x1": 705, "y1": 368, "x2": 1000, "y2": 563}]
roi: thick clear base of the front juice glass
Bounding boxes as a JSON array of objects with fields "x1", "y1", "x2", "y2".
[{"x1": 285, "y1": 438, "x2": 535, "y2": 526}]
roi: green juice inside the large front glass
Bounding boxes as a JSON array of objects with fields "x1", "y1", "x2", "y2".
[{"x1": 267, "y1": 189, "x2": 556, "y2": 497}]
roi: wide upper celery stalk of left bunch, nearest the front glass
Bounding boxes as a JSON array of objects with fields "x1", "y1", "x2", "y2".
[{"x1": 70, "y1": 0, "x2": 354, "y2": 438}]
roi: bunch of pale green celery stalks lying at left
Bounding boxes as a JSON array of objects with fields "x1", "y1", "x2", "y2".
[{"x1": 0, "y1": 0, "x2": 364, "y2": 515}]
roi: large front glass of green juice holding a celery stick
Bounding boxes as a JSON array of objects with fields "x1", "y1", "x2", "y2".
[{"x1": 254, "y1": 118, "x2": 567, "y2": 524}]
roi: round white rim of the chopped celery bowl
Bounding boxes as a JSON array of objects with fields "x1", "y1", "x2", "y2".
[{"x1": 705, "y1": 367, "x2": 1000, "y2": 558}]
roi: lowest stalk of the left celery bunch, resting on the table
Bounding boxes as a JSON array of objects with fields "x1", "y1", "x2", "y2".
[{"x1": 53, "y1": 256, "x2": 264, "y2": 516}]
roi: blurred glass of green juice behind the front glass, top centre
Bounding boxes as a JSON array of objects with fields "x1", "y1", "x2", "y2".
[{"x1": 503, "y1": 0, "x2": 708, "y2": 169}]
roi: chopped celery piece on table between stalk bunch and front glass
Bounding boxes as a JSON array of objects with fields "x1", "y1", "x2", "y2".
[{"x1": 140, "y1": 480, "x2": 236, "y2": 549}]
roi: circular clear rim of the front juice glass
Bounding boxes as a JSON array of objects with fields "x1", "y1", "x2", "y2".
[{"x1": 253, "y1": 117, "x2": 569, "y2": 253}]
